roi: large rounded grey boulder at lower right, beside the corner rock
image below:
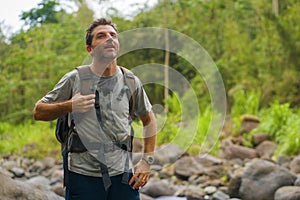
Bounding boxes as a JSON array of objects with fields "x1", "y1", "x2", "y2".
[{"x1": 239, "y1": 160, "x2": 296, "y2": 200}]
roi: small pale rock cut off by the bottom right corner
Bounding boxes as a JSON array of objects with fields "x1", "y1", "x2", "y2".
[{"x1": 274, "y1": 186, "x2": 300, "y2": 200}]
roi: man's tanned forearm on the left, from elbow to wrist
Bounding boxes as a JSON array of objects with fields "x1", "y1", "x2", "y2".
[{"x1": 33, "y1": 100, "x2": 72, "y2": 121}]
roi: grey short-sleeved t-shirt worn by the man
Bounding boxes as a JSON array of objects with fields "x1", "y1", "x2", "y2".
[{"x1": 42, "y1": 68, "x2": 151, "y2": 177}]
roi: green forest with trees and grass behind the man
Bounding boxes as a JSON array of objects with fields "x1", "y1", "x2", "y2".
[{"x1": 0, "y1": 0, "x2": 300, "y2": 157}]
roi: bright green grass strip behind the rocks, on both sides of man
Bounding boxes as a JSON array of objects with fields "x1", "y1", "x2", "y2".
[{"x1": 0, "y1": 103, "x2": 300, "y2": 158}]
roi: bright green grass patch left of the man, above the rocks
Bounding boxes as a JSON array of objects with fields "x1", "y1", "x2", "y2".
[{"x1": 0, "y1": 122, "x2": 60, "y2": 158}]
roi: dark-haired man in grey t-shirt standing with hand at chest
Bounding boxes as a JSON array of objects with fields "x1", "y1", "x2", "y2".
[{"x1": 34, "y1": 18, "x2": 156, "y2": 200}]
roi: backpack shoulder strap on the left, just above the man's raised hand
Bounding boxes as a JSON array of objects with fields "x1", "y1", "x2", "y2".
[{"x1": 76, "y1": 65, "x2": 94, "y2": 95}]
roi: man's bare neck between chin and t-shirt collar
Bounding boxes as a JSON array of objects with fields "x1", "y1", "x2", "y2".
[{"x1": 91, "y1": 60, "x2": 117, "y2": 77}]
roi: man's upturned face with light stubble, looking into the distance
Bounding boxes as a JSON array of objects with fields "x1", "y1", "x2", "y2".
[{"x1": 90, "y1": 25, "x2": 119, "y2": 60}]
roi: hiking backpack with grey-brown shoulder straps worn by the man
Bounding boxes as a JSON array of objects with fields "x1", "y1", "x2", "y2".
[{"x1": 55, "y1": 65, "x2": 137, "y2": 186}]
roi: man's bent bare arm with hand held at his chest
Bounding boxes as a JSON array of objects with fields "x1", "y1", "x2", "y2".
[{"x1": 33, "y1": 93, "x2": 95, "y2": 121}]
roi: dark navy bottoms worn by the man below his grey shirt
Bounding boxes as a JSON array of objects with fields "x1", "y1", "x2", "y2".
[{"x1": 66, "y1": 172, "x2": 140, "y2": 200}]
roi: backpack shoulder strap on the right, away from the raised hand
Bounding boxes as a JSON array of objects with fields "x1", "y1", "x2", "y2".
[{"x1": 120, "y1": 67, "x2": 137, "y2": 120}]
